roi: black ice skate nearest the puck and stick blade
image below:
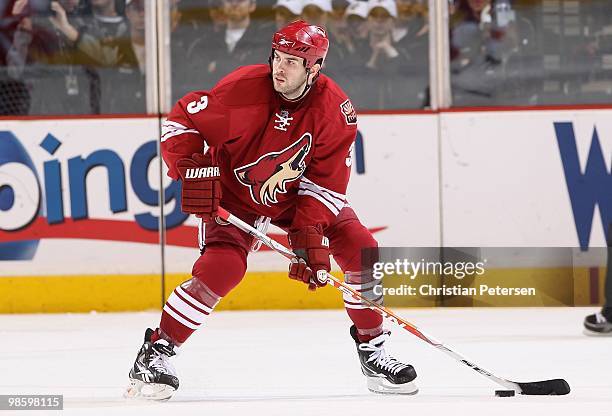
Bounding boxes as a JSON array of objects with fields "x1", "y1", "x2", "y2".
[{"x1": 351, "y1": 325, "x2": 418, "y2": 394}]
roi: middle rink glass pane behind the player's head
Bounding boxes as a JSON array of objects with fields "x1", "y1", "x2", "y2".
[{"x1": 169, "y1": 0, "x2": 429, "y2": 110}]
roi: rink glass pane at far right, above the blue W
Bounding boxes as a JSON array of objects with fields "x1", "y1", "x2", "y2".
[{"x1": 450, "y1": 0, "x2": 612, "y2": 107}]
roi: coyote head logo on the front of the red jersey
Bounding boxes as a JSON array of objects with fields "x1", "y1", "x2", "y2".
[{"x1": 234, "y1": 133, "x2": 312, "y2": 206}]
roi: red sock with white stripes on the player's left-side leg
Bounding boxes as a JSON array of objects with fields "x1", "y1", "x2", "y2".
[{"x1": 158, "y1": 243, "x2": 246, "y2": 346}]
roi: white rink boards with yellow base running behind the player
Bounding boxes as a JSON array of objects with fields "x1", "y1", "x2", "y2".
[{"x1": 0, "y1": 110, "x2": 612, "y2": 312}]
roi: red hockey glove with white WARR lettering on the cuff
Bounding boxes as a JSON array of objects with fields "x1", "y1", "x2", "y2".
[{"x1": 176, "y1": 153, "x2": 221, "y2": 222}]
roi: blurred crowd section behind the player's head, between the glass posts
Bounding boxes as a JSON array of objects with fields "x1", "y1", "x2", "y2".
[{"x1": 171, "y1": 0, "x2": 429, "y2": 109}]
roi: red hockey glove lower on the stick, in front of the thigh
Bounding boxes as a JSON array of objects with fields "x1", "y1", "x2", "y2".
[{"x1": 289, "y1": 227, "x2": 331, "y2": 290}]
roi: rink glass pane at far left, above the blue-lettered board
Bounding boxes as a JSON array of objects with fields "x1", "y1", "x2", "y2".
[{"x1": 0, "y1": 0, "x2": 148, "y2": 116}]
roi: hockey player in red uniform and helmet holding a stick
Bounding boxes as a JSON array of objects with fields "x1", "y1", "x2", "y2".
[{"x1": 127, "y1": 21, "x2": 417, "y2": 400}]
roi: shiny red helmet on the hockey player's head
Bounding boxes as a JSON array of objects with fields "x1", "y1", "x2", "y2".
[{"x1": 272, "y1": 20, "x2": 329, "y2": 68}]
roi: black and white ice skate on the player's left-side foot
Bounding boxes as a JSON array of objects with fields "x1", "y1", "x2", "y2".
[{"x1": 125, "y1": 328, "x2": 179, "y2": 400}]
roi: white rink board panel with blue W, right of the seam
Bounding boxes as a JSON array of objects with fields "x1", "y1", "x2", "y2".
[{"x1": 440, "y1": 110, "x2": 612, "y2": 248}]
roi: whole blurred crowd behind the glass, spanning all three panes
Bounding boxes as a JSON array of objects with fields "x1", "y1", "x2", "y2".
[{"x1": 0, "y1": 0, "x2": 612, "y2": 115}]
